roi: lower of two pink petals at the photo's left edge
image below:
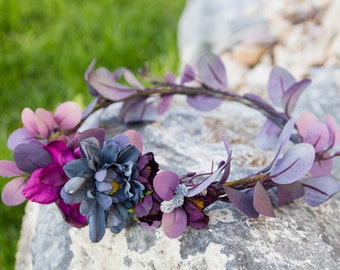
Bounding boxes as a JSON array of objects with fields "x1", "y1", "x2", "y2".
[{"x1": 1, "y1": 177, "x2": 27, "y2": 206}]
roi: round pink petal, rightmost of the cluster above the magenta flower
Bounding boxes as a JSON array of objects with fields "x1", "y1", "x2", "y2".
[{"x1": 54, "y1": 101, "x2": 82, "y2": 130}]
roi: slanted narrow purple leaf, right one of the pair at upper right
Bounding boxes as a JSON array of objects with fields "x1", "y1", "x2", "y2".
[{"x1": 281, "y1": 79, "x2": 311, "y2": 115}]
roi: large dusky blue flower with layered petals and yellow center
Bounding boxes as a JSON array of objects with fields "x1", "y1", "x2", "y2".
[{"x1": 61, "y1": 129, "x2": 144, "y2": 242}]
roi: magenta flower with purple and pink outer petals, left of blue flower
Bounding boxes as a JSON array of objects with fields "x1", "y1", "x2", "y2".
[{"x1": 0, "y1": 141, "x2": 86, "y2": 227}]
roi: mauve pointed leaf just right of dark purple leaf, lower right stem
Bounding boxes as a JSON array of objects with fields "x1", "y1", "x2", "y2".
[{"x1": 253, "y1": 181, "x2": 275, "y2": 217}]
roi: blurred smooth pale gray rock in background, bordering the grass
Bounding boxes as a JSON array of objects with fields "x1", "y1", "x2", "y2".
[{"x1": 178, "y1": 0, "x2": 275, "y2": 66}]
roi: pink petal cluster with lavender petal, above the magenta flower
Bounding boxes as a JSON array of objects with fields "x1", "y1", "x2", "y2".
[{"x1": 7, "y1": 101, "x2": 81, "y2": 149}]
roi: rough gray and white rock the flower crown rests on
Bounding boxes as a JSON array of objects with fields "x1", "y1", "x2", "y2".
[{"x1": 16, "y1": 71, "x2": 340, "y2": 270}]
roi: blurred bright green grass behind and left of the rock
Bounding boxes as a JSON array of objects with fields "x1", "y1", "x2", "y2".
[{"x1": 0, "y1": 0, "x2": 185, "y2": 269}]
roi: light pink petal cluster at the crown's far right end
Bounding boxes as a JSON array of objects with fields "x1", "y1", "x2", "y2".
[{"x1": 297, "y1": 112, "x2": 340, "y2": 176}]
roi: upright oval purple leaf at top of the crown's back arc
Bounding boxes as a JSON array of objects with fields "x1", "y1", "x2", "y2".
[{"x1": 197, "y1": 53, "x2": 227, "y2": 90}]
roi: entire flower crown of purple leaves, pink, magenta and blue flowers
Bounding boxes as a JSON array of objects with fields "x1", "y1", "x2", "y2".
[{"x1": 0, "y1": 53, "x2": 340, "y2": 242}]
